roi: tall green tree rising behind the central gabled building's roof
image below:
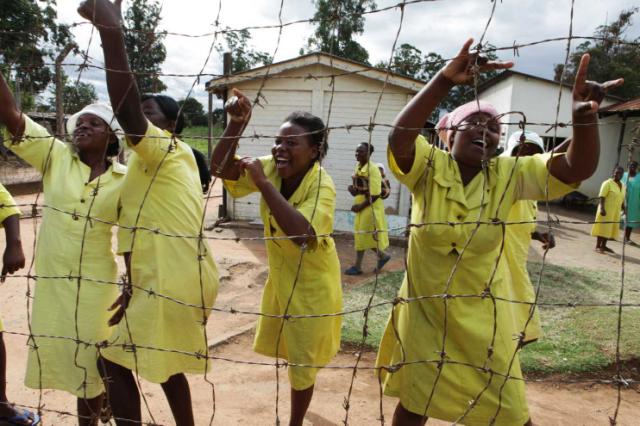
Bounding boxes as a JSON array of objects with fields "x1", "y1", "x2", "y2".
[{"x1": 307, "y1": 0, "x2": 376, "y2": 65}]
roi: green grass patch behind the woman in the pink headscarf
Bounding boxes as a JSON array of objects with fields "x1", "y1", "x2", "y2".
[{"x1": 342, "y1": 263, "x2": 640, "y2": 374}]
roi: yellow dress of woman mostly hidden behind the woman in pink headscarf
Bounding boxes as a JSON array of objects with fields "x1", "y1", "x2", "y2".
[{"x1": 504, "y1": 200, "x2": 542, "y2": 342}]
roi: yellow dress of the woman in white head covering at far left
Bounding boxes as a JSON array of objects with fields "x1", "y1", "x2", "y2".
[{"x1": 4, "y1": 117, "x2": 126, "y2": 398}]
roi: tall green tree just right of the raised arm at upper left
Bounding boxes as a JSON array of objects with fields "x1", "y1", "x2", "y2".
[{"x1": 124, "y1": 0, "x2": 167, "y2": 93}]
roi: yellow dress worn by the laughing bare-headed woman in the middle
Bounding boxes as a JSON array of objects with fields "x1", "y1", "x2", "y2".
[{"x1": 224, "y1": 156, "x2": 342, "y2": 390}]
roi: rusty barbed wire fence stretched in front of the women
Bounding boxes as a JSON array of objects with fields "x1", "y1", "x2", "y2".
[{"x1": 4, "y1": 0, "x2": 640, "y2": 424}]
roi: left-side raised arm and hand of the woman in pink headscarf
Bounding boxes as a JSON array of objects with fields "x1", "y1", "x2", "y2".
[{"x1": 389, "y1": 39, "x2": 513, "y2": 173}]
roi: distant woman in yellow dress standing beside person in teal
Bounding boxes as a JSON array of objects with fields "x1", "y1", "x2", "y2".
[{"x1": 591, "y1": 166, "x2": 625, "y2": 253}]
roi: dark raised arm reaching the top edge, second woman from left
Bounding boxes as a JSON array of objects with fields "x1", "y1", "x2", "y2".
[{"x1": 78, "y1": 0, "x2": 148, "y2": 145}]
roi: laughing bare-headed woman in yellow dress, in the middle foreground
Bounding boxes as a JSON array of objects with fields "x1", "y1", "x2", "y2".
[{"x1": 211, "y1": 91, "x2": 342, "y2": 425}]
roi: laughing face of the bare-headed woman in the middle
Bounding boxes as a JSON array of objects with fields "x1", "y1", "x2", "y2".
[{"x1": 271, "y1": 121, "x2": 318, "y2": 180}]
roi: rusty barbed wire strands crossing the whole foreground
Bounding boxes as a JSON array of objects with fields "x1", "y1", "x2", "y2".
[{"x1": 0, "y1": 0, "x2": 640, "y2": 424}]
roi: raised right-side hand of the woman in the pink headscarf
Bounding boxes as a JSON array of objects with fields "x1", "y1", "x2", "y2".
[{"x1": 572, "y1": 53, "x2": 624, "y2": 117}]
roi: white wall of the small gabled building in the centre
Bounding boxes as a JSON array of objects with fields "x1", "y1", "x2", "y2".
[{"x1": 228, "y1": 64, "x2": 413, "y2": 223}]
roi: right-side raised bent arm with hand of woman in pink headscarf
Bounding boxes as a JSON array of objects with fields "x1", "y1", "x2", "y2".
[{"x1": 549, "y1": 54, "x2": 624, "y2": 184}]
